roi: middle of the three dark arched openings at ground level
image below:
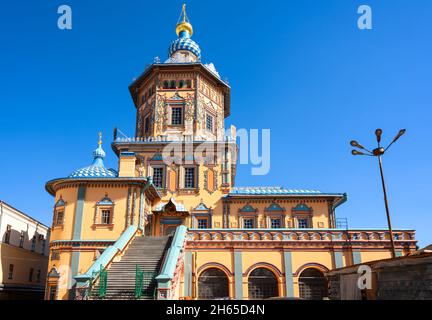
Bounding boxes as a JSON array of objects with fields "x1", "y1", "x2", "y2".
[{"x1": 248, "y1": 268, "x2": 279, "y2": 299}]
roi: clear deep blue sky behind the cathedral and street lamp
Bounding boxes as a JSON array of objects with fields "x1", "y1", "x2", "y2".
[{"x1": 0, "y1": 0, "x2": 432, "y2": 246}]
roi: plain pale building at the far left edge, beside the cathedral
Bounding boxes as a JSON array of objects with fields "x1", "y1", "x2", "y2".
[{"x1": 0, "y1": 201, "x2": 50, "y2": 300}]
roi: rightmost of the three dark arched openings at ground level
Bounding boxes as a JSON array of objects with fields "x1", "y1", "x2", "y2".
[{"x1": 299, "y1": 268, "x2": 328, "y2": 300}]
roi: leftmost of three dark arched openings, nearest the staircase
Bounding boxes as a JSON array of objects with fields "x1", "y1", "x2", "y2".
[{"x1": 198, "y1": 268, "x2": 229, "y2": 299}]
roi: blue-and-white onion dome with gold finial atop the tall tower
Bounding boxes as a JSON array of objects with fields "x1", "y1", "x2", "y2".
[{"x1": 168, "y1": 4, "x2": 201, "y2": 60}]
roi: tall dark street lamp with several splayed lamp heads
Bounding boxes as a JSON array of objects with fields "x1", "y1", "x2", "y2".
[{"x1": 350, "y1": 129, "x2": 406, "y2": 258}]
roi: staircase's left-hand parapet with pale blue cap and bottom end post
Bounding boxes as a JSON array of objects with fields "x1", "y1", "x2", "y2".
[{"x1": 74, "y1": 226, "x2": 138, "y2": 300}]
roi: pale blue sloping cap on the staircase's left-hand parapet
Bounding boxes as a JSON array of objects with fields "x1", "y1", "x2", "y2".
[{"x1": 74, "y1": 226, "x2": 138, "y2": 287}]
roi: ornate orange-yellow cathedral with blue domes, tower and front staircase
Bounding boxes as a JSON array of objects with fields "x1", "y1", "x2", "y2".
[{"x1": 46, "y1": 7, "x2": 416, "y2": 300}]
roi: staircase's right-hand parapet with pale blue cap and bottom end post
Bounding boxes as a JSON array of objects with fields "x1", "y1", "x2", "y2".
[{"x1": 156, "y1": 226, "x2": 187, "y2": 300}]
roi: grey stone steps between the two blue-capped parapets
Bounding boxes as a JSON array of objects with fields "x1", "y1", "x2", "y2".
[{"x1": 90, "y1": 236, "x2": 172, "y2": 300}]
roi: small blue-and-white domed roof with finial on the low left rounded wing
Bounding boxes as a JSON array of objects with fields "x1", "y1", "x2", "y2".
[{"x1": 68, "y1": 134, "x2": 118, "y2": 179}]
